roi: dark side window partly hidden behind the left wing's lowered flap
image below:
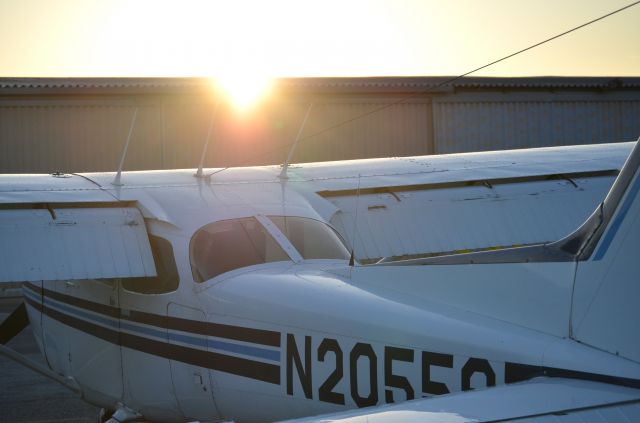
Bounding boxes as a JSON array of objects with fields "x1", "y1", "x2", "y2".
[{"x1": 122, "y1": 235, "x2": 180, "y2": 294}]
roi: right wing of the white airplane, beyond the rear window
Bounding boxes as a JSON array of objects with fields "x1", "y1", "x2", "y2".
[{"x1": 290, "y1": 142, "x2": 635, "y2": 263}]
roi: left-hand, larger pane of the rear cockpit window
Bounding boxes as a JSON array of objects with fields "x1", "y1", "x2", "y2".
[{"x1": 189, "y1": 217, "x2": 290, "y2": 282}]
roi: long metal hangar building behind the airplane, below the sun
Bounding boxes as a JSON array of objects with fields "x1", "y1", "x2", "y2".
[{"x1": 0, "y1": 77, "x2": 640, "y2": 173}]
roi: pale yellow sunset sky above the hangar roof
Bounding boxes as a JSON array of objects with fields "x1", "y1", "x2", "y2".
[{"x1": 0, "y1": 0, "x2": 640, "y2": 81}]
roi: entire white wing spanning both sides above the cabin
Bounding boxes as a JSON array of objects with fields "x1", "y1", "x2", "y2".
[{"x1": 0, "y1": 142, "x2": 635, "y2": 282}]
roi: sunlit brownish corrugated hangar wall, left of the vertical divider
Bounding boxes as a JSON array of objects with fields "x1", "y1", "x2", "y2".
[{"x1": 0, "y1": 99, "x2": 433, "y2": 173}]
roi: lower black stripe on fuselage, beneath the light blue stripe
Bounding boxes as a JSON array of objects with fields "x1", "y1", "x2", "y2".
[{"x1": 24, "y1": 284, "x2": 280, "y2": 385}]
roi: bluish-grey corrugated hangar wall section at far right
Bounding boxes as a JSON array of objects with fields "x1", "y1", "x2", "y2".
[{"x1": 434, "y1": 100, "x2": 640, "y2": 154}]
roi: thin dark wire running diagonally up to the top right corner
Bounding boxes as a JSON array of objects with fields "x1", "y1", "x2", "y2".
[{"x1": 209, "y1": 0, "x2": 640, "y2": 176}]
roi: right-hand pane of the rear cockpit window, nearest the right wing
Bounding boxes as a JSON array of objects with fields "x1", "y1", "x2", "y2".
[{"x1": 269, "y1": 216, "x2": 349, "y2": 260}]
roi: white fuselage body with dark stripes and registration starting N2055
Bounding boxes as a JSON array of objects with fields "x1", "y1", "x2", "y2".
[{"x1": 24, "y1": 261, "x2": 640, "y2": 421}]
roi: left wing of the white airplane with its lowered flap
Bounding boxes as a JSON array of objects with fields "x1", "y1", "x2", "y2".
[{"x1": 0, "y1": 175, "x2": 156, "y2": 283}]
